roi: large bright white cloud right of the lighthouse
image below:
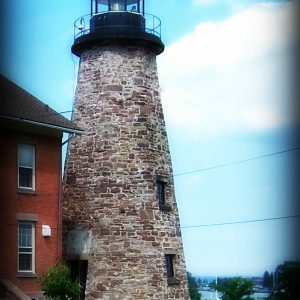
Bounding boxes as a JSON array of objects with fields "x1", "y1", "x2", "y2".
[{"x1": 158, "y1": 2, "x2": 295, "y2": 136}]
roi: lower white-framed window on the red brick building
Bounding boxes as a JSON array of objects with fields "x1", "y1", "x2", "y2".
[{"x1": 18, "y1": 221, "x2": 35, "y2": 273}]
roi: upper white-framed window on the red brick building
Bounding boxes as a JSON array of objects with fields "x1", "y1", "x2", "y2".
[{"x1": 18, "y1": 144, "x2": 35, "y2": 190}]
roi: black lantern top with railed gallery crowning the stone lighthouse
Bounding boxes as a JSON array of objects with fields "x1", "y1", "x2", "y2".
[{"x1": 72, "y1": 0, "x2": 164, "y2": 56}]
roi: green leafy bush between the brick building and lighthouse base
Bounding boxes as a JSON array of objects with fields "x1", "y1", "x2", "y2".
[{"x1": 38, "y1": 263, "x2": 81, "y2": 300}]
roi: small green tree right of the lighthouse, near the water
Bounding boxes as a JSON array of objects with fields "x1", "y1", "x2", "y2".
[{"x1": 215, "y1": 277, "x2": 254, "y2": 300}]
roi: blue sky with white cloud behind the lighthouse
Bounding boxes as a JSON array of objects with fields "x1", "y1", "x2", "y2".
[{"x1": 0, "y1": 0, "x2": 300, "y2": 275}]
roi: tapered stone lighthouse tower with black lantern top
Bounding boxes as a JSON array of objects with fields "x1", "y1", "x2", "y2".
[{"x1": 63, "y1": 0, "x2": 189, "y2": 300}]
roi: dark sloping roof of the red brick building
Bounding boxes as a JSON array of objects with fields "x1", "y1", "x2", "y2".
[{"x1": 0, "y1": 74, "x2": 83, "y2": 133}]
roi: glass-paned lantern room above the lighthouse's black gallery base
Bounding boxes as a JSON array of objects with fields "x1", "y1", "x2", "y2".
[{"x1": 91, "y1": 0, "x2": 145, "y2": 15}]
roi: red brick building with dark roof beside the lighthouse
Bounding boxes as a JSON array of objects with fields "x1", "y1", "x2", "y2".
[{"x1": 0, "y1": 76, "x2": 81, "y2": 298}]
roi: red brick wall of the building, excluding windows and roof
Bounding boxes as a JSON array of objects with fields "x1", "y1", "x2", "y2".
[{"x1": 0, "y1": 129, "x2": 62, "y2": 292}]
